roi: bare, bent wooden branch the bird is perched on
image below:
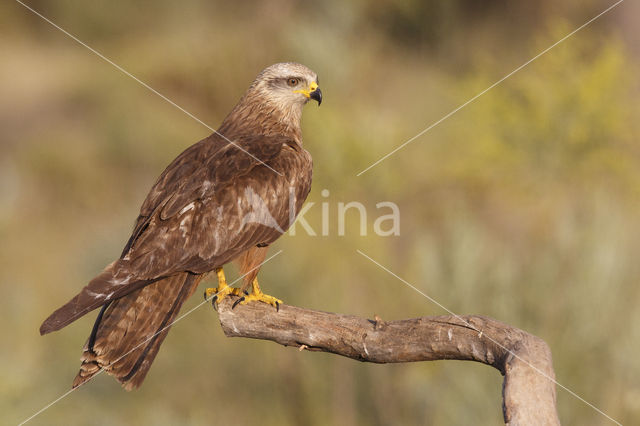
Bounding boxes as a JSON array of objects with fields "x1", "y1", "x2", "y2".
[{"x1": 218, "y1": 297, "x2": 560, "y2": 426}]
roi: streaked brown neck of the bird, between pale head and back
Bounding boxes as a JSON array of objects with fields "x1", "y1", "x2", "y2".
[{"x1": 218, "y1": 93, "x2": 302, "y2": 145}]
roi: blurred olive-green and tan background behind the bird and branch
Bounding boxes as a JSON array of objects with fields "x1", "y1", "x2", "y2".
[{"x1": 0, "y1": 0, "x2": 640, "y2": 425}]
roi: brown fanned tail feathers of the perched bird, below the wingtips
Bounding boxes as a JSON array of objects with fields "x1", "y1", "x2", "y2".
[{"x1": 73, "y1": 272, "x2": 202, "y2": 390}]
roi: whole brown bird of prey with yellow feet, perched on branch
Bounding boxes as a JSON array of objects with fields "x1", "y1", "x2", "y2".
[{"x1": 40, "y1": 63, "x2": 322, "y2": 390}]
